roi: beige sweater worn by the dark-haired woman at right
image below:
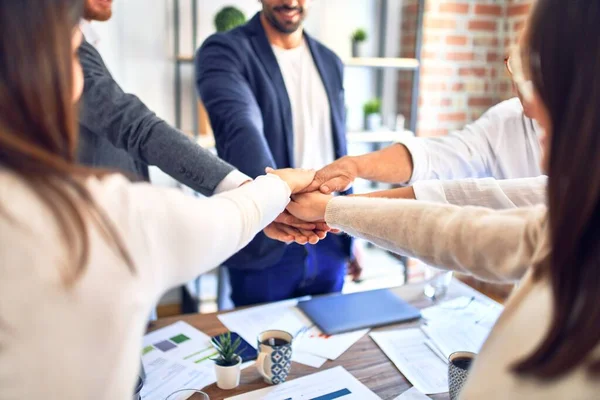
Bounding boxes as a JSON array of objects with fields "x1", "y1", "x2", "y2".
[{"x1": 325, "y1": 197, "x2": 600, "y2": 400}]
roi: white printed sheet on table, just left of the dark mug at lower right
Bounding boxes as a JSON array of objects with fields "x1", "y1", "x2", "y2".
[{"x1": 370, "y1": 328, "x2": 448, "y2": 394}]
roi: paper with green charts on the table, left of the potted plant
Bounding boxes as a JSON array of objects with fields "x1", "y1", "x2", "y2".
[{"x1": 142, "y1": 322, "x2": 216, "y2": 400}]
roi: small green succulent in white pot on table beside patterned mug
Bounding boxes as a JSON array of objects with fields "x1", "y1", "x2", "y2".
[{"x1": 212, "y1": 332, "x2": 243, "y2": 390}]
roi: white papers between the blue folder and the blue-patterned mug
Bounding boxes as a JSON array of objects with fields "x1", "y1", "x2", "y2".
[{"x1": 219, "y1": 300, "x2": 369, "y2": 368}]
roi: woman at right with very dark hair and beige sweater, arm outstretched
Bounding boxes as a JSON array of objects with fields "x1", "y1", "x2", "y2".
[{"x1": 289, "y1": 0, "x2": 600, "y2": 400}]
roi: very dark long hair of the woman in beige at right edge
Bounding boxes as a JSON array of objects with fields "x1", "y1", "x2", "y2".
[{"x1": 516, "y1": 0, "x2": 600, "y2": 379}]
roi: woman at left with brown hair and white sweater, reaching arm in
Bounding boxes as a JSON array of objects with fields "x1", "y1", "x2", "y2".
[{"x1": 0, "y1": 0, "x2": 314, "y2": 400}]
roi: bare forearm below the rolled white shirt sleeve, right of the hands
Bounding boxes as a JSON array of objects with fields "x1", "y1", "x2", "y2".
[{"x1": 351, "y1": 144, "x2": 413, "y2": 183}]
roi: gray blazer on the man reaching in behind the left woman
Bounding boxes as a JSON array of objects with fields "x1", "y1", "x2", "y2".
[{"x1": 78, "y1": 41, "x2": 234, "y2": 195}]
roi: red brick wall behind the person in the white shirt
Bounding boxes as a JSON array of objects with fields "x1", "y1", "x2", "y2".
[{"x1": 398, "y1": 0, "x2": 534, "y2": 136}]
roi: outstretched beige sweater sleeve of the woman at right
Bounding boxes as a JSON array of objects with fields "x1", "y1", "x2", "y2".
[{"x1": 325, "y1": 198, "x2": 547, "y2": 281}]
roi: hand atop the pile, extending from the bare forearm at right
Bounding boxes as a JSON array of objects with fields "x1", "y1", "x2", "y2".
[{"x1": 301, "y1": 156, "x2": 358, "y2": 194}]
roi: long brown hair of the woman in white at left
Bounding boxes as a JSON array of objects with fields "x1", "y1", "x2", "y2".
[{"x1": 0, "y1": 0, "x2": 133, "y2": 283}]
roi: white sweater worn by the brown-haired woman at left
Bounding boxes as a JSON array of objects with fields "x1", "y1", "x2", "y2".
[{"x1": 0, "y1": 170, "x2": 290, "y2": 400}]
